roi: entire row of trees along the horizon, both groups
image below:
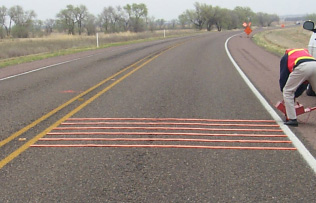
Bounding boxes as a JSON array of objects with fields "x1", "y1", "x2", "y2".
[{"x1": 0, "y1": 2, "x2": 312, "y2": 38}]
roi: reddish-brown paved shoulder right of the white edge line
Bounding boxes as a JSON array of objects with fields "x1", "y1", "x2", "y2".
[{"x1": 228, "y1": 31, "x2": 316, "y2": 156}]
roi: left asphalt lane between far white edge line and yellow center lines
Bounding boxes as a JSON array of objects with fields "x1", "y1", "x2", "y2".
[{"x1": 0, "y1": 36, "x2": 185, "y2": 159}]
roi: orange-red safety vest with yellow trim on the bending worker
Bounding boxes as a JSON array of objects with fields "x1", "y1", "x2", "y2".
[{"x1": 285, "y1": 49, "x2": 315, "y2": 73}]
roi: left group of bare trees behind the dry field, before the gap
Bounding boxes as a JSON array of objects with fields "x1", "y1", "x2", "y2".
[{"x1": 0, "y1": 4, "x2": 150, "y2": 38}]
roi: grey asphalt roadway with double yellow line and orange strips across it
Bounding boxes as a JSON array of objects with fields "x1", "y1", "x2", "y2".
[{"x1": 0, "y1": 29, "x2": 316, "y2": 202}]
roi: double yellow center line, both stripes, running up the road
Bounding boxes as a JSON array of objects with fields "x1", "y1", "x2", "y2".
[{"x1": 0, "y1": 42, "x2": 183, "y2": 169}]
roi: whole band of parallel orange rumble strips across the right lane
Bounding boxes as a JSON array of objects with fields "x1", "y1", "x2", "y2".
[{"x1": 31, "y1": 118, "x2": 290, "y2": 150}]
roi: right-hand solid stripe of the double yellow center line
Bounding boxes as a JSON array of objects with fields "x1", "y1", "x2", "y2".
[{"x1": 0, "y1": 43, "x2": 183, "y2": 169}]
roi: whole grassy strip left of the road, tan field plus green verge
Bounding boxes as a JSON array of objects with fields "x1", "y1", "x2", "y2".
[{"x1": 0, "y1": 30, "x2": 199, "y2": 68}]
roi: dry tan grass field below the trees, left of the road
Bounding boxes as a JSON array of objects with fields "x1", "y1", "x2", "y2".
[{"x1": 0, "y1": 30, "x2": 200, "y2": 60}]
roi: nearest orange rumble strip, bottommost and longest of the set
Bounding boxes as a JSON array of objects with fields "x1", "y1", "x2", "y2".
[{"x1": 31, "y1": 144, "x2": 296, "y2": 150}]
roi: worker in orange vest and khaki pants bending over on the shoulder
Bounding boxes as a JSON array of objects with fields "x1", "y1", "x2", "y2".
[{"x1": 279, "y1": 49, "x2": 316, "y2": 126}]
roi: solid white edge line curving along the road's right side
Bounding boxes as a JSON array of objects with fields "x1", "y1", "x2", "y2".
[{"x1": 225, "y1": 34, "x2": 316, "y2": 173}]
